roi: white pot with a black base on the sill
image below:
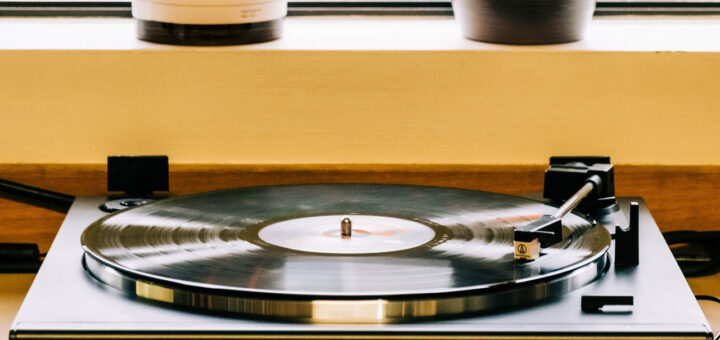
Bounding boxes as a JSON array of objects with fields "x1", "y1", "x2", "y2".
[{"x1": 132, "y1": 0, "x2": 287, "y2": 46}]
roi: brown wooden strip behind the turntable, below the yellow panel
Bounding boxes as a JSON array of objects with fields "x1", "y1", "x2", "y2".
[{"x1": 0, "y1": 164, "x2": 720, "y2": 251}]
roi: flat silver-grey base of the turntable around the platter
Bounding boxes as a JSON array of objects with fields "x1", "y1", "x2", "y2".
[{"x1": 7, "y1": 197, "x2": 709, "y2": 339}]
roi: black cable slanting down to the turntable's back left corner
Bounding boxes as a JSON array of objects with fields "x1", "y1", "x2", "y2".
[{"x1": 0, "y1": 179, "x2": 75, "y2": 213}]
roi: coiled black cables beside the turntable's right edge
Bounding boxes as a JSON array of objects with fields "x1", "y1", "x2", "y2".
[{"x1": 663, "y1": 230, "x2": 720, "y2": 277}]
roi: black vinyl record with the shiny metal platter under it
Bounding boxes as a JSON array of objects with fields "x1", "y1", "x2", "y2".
[{"x1": 82, "y1": 184, "x2": 610, "y2": 322}]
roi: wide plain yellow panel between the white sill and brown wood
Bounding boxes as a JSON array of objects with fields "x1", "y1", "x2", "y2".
[{"x1": 0, "y1": 49, "x2": 720, "y2": 164}]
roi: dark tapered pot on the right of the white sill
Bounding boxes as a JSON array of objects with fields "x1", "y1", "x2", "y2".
[{"x1": 452, "y1": 0, "x2": 595, "y2": 44}]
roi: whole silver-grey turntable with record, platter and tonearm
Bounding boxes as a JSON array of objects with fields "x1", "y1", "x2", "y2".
[{"x1": 10, "y1": 158, "x2": 712, "y2": 339}]
